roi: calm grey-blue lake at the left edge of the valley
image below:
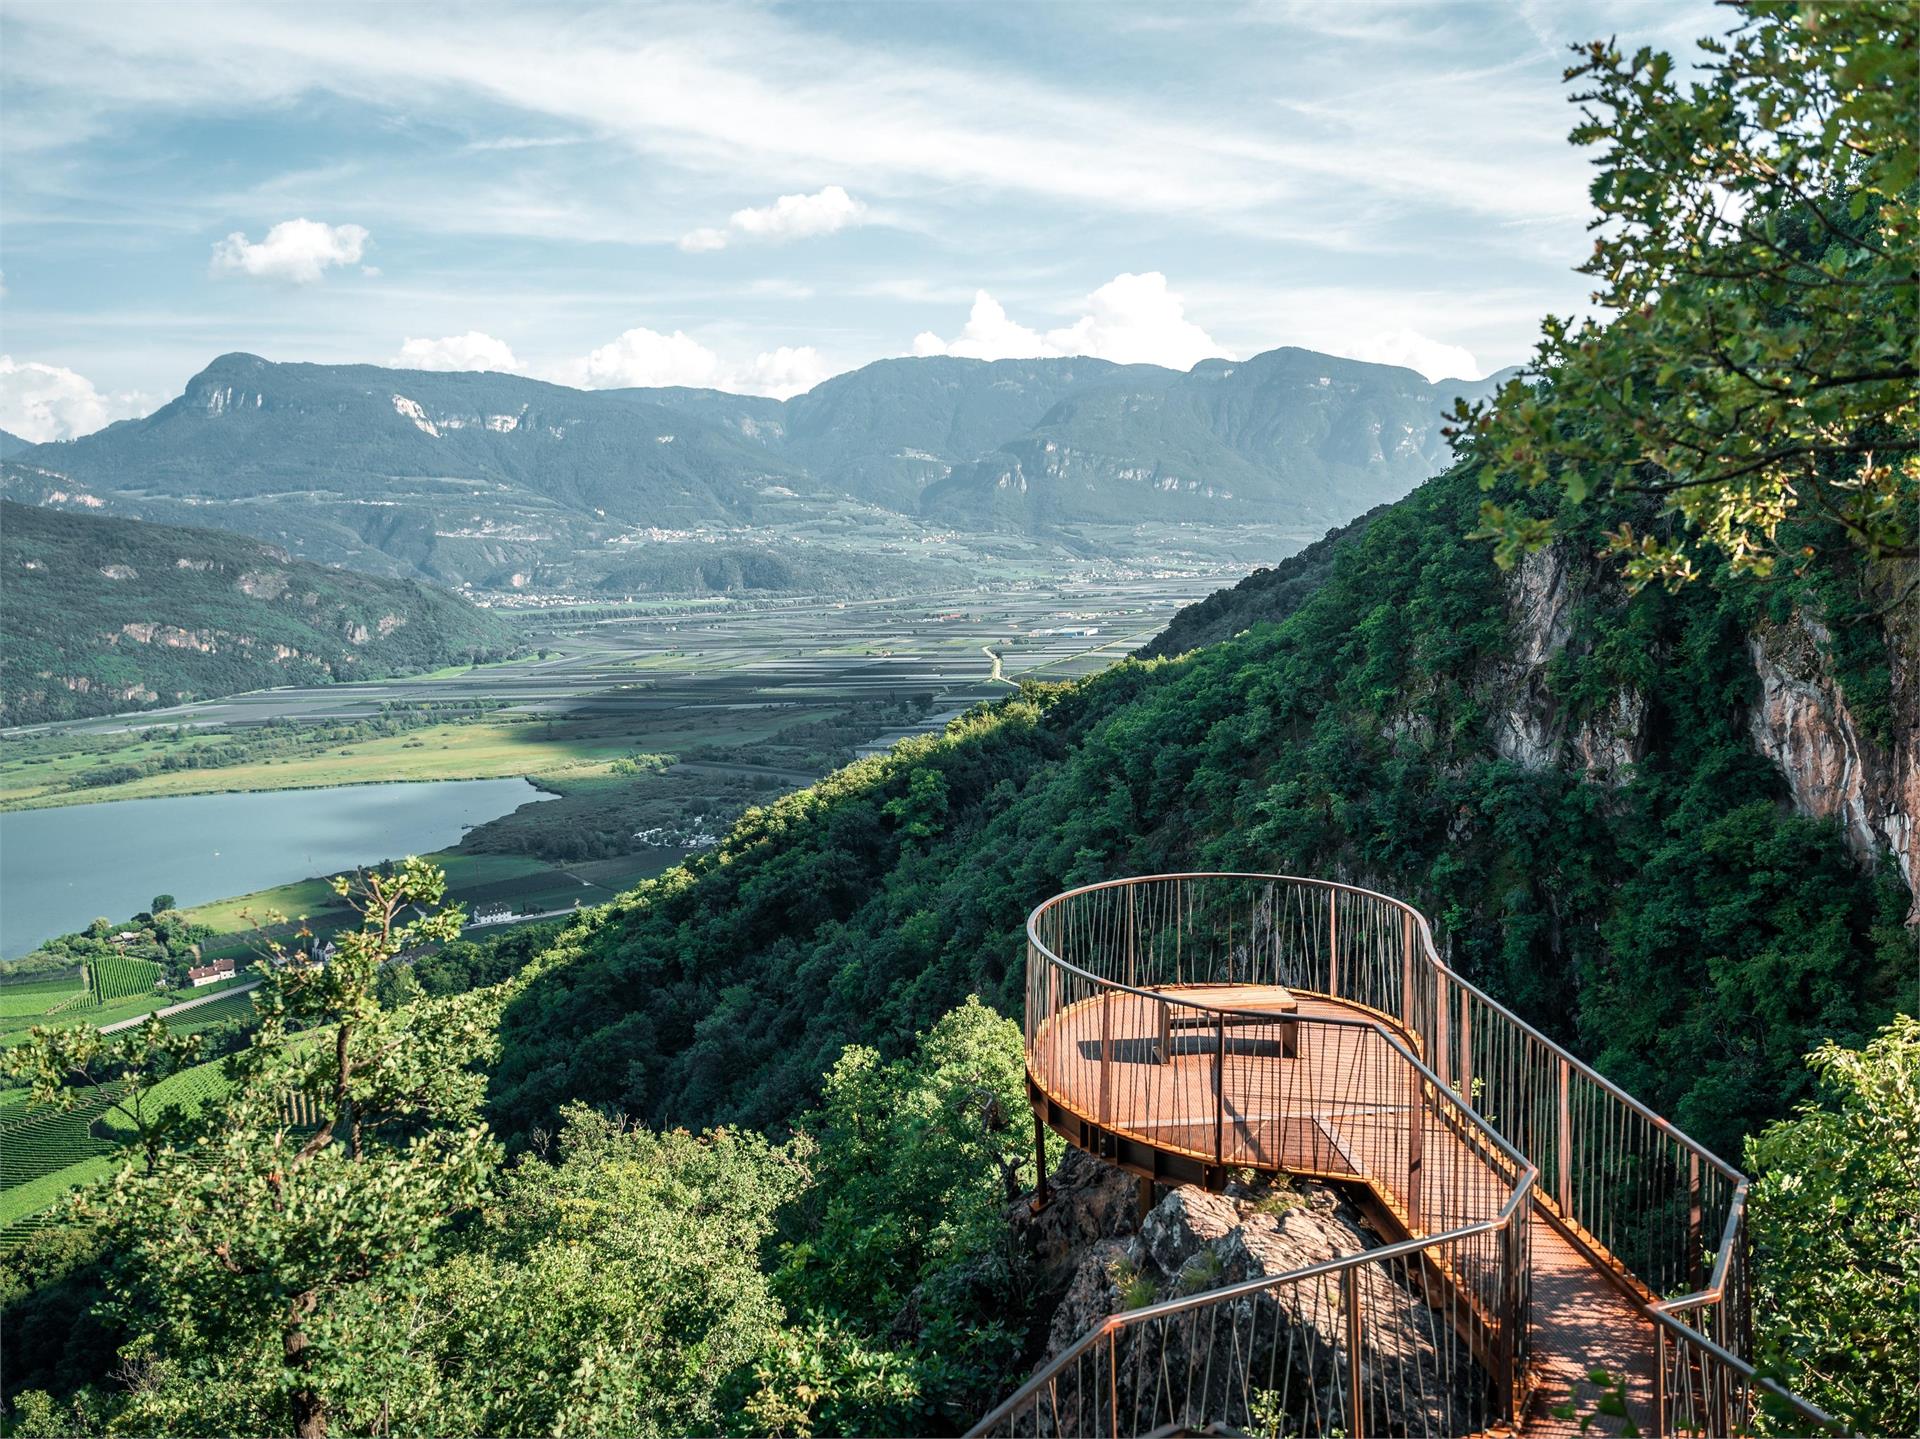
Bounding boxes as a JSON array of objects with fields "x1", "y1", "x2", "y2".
[{"x1": 0, "y1": 780, "x2": 553, "y2": 959}]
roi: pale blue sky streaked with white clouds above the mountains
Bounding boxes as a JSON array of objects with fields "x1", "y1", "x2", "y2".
[{"x1": 0, "y1": 0, "x2": 1726, "y2": 440}]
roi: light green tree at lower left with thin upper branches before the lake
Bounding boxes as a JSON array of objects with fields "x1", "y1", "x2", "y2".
[{"x1": 15, "y1": 859, "x2": 497, "y2": 1439}]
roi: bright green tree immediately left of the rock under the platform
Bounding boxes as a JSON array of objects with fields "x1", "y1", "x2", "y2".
[{"x1": 745, "y1": 995, "x2": 1033, "y2": 1433}]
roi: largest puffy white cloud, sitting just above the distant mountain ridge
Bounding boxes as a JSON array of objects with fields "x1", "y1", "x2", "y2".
[{"x1": 914, "y1": 271, "x2": 1229, "y2": 369}]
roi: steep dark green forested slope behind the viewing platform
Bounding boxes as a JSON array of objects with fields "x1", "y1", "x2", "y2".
[{"x1": 493, "y1": 455, "x2": 1914, "y2": 1153}]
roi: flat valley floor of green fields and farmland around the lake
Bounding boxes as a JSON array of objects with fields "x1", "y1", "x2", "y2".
[{"x1": 0, "y1": 578, "x2": 1213, "y2": 1237}]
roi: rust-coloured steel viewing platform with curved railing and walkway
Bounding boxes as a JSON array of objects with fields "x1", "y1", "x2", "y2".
[{"x1": 973, "y1": 874, "x2": 1836, "y2": 1439}]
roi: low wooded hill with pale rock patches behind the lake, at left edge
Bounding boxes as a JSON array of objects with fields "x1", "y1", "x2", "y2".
[{"x1": 0, "y1": 501, "x2": 516, "y2": 724}]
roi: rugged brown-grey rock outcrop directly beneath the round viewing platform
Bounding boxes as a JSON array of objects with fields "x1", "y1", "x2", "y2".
[{"x1": 1008, "y1": 1151, "x2": 1488, "y2": 1433}]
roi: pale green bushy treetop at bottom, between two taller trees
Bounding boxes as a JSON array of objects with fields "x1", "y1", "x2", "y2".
[{"x1": 389, "y1": 1107, "x2": 810, "y2": 1435}]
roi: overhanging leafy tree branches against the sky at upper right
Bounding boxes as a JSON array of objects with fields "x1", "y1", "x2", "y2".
[{"x1": 1453, "y1": 0, "x2": 1920, "y2": 586}]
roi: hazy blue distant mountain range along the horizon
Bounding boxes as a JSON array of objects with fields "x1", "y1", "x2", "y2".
[{"x1": 0, "y1": 350, "x2": 1503, "y2": 592}]
